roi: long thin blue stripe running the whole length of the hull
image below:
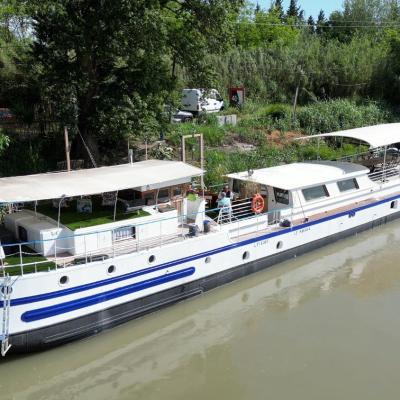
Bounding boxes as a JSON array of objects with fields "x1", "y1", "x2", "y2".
[{"x1": 0, "y1": 195, "x2": 400, "y2": 307}]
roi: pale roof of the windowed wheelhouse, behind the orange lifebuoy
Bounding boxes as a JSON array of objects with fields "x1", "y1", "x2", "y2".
[{"x1": 228, "y1": 161, "x2": 369, "y2": 190}]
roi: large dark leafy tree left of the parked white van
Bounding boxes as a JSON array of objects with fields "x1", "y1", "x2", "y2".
[{"x1": 32, "y1": 0, "x2": 243, "y2": 159}]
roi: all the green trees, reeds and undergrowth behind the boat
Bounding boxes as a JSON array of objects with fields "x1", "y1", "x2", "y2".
[{"x1": 0, "y1": 0, "x2": 400, "y2": 181}]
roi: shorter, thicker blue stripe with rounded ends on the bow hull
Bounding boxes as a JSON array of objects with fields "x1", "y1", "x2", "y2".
[{"x1": 21, "y1": 267, "x2": 195, "y2": 322}]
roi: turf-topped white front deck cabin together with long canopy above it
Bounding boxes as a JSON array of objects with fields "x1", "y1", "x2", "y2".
[{"x1": 0, "y1": 160, "x2": 205, "y2": 257}]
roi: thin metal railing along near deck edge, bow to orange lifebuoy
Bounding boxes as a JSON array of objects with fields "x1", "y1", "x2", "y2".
[{"x1": 0, "y1": 199, "x2": 290, "y2": 277}]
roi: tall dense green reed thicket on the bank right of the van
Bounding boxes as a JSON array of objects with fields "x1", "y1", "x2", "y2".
[{"x1": 214, "y1": 32, "x2": 387, "y2": 104}]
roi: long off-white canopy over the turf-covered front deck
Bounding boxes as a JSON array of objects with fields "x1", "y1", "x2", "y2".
[{"x1": 0, "y1": 160, "x2": 204, "y2": 203}]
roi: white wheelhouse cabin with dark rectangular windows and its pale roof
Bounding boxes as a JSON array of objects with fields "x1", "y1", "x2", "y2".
[{"x1": 228, "y1": 161, "x2": 376, "y2": 222}]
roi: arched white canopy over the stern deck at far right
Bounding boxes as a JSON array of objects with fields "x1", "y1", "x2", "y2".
[{"x1": 296, "y1": 123, "x2": 400, "y2": 148}]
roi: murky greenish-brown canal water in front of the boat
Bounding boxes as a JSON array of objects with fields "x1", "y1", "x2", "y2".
[{"x1": 0, "y1": 222, "x2": 400, "y2": 400}]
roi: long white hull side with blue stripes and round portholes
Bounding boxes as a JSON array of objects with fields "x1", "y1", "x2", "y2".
[{"x1": 0, "y1": 182, "x2": 400, "y2": 351}]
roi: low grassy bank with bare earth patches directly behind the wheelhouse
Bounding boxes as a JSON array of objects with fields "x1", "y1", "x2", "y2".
[{"x1": 167, "y1": 99, "x2": 388, "y2": 186}]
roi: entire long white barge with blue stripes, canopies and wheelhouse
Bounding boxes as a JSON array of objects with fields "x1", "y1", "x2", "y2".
[{"x1": 0, "y1": 124, "x2": 400, "y2": 355}]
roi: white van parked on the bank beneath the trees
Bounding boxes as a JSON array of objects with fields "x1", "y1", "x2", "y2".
[{"x1": 182, "y1": 89, "x2": 224, "y2": 114}]
